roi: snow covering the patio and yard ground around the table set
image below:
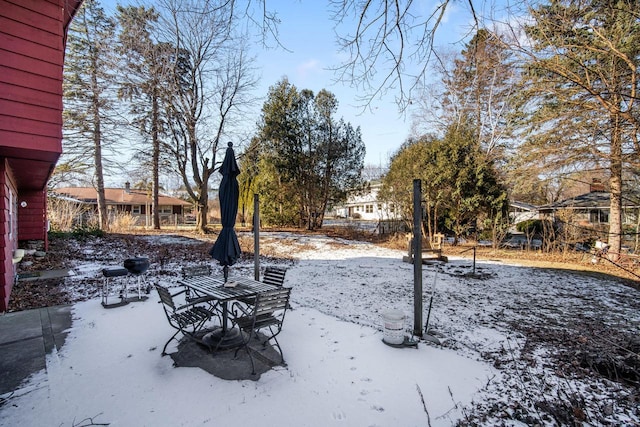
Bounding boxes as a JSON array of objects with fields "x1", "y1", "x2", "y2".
[{"x1": 0, "y1": 233, "x2": 640, "y2": 427}]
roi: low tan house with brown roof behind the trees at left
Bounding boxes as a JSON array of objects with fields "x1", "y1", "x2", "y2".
[{"x1": 54, "y1": 182, "x2": 192, "y2": 225}]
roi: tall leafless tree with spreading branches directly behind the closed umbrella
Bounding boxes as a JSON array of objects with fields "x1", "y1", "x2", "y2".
[{"x1": 158, "y1": 0, "x2": 256, "y2": 232}]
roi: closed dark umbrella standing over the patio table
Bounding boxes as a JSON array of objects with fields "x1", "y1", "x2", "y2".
[{"x1": 209, "y1": 142, "x2": 241, "y2": 280}]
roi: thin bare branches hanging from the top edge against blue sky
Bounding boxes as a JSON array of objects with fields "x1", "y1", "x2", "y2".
[{"x1": 329, "y1": 0, "x2": 478, "y2": 111}]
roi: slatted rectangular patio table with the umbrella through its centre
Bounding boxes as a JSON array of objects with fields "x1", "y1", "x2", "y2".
[{"x1": 178, "y1": 276, "x2": 278, "y2": 350}]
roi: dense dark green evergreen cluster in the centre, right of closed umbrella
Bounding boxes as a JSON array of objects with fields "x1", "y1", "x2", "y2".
[{"x1": 254, "y1": 79, "x2": 365, "y2": 229}]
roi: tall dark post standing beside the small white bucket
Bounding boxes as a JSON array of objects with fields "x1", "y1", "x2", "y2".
[{"x1": 413, "y1": 179, "x2": 422, "y2": 337}]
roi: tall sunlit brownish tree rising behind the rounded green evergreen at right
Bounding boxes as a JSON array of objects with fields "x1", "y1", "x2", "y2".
[{"x1": 413, "y1": 29, "x2": 519, "y2": 161}]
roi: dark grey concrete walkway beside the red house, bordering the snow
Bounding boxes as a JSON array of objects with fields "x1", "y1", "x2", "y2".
[{"x1": 0, "y1": 306, "x2": 71, "y2": 399}]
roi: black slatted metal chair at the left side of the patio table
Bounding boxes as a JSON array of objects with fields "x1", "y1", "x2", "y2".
[{"x1": 156, "y1": 285, "x2": 215, "y2": 356}]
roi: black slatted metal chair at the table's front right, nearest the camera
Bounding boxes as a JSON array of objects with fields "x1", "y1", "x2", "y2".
[{"x1": 232, "y1": 287, "x2": 291, "y2": 375}]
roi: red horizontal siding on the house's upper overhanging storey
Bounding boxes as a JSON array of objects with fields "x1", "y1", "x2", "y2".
[{"x1": 0, "y1": 0, "x2": 64, "y2": 161}]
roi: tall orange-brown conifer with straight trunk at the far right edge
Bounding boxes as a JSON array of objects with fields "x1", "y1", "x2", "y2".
[{"x1": 519, "y1": 0, "x2": 640, "y2": 259}]
